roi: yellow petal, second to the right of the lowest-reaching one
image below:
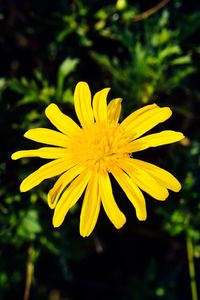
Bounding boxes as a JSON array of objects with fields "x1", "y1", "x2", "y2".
[{"x1": 112, "y1": 168, "x2": 147, "y2": 221}]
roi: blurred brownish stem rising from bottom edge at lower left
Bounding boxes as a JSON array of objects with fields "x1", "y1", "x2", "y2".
[{"x1": 23, "y1": 245, "x2": 35, "y2": 300}]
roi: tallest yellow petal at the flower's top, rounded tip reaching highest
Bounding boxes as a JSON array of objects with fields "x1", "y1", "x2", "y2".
[{"x1": 74, "y1": 81, "x2": 94, "y2": 127}]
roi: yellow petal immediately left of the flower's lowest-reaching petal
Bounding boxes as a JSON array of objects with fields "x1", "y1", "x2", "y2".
[{"x1": 53, "y1": 170, "x2": 91, "y2": 227}]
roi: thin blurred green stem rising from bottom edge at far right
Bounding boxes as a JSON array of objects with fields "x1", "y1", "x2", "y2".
[{"x1": 186, "y1": 234, "x2": 198, "y2": 300}]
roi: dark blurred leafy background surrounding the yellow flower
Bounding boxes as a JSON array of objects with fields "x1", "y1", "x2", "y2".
[{"x1": 0, "y1": 0, "x2": 200, "y2": 300}]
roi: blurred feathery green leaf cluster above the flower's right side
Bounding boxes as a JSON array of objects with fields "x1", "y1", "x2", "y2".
[{"x1": 91, "y1": 10, "x2": 195, "y2": 104}]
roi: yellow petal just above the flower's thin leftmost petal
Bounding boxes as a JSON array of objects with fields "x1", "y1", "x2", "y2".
[{"x1": 24, "y1": 128, "x2": 69, "y2": 147}]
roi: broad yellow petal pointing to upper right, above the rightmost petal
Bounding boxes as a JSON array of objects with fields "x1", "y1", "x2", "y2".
[{"x1": 120, "y1": 106, "x2": 172, "y2": 140}]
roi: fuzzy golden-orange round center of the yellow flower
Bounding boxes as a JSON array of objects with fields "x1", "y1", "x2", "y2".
[{"x1": 71, "y1": 122, "x2": 129, "y2": 171}]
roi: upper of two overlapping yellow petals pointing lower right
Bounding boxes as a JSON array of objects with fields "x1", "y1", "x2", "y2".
[{"x1": 133, "y1": 159, "x2": 181, "y2": 192}]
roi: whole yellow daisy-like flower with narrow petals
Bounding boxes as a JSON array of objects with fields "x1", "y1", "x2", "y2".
[{"x1": 12, "y1": 82, "x2": 184, "y2": 236}]
